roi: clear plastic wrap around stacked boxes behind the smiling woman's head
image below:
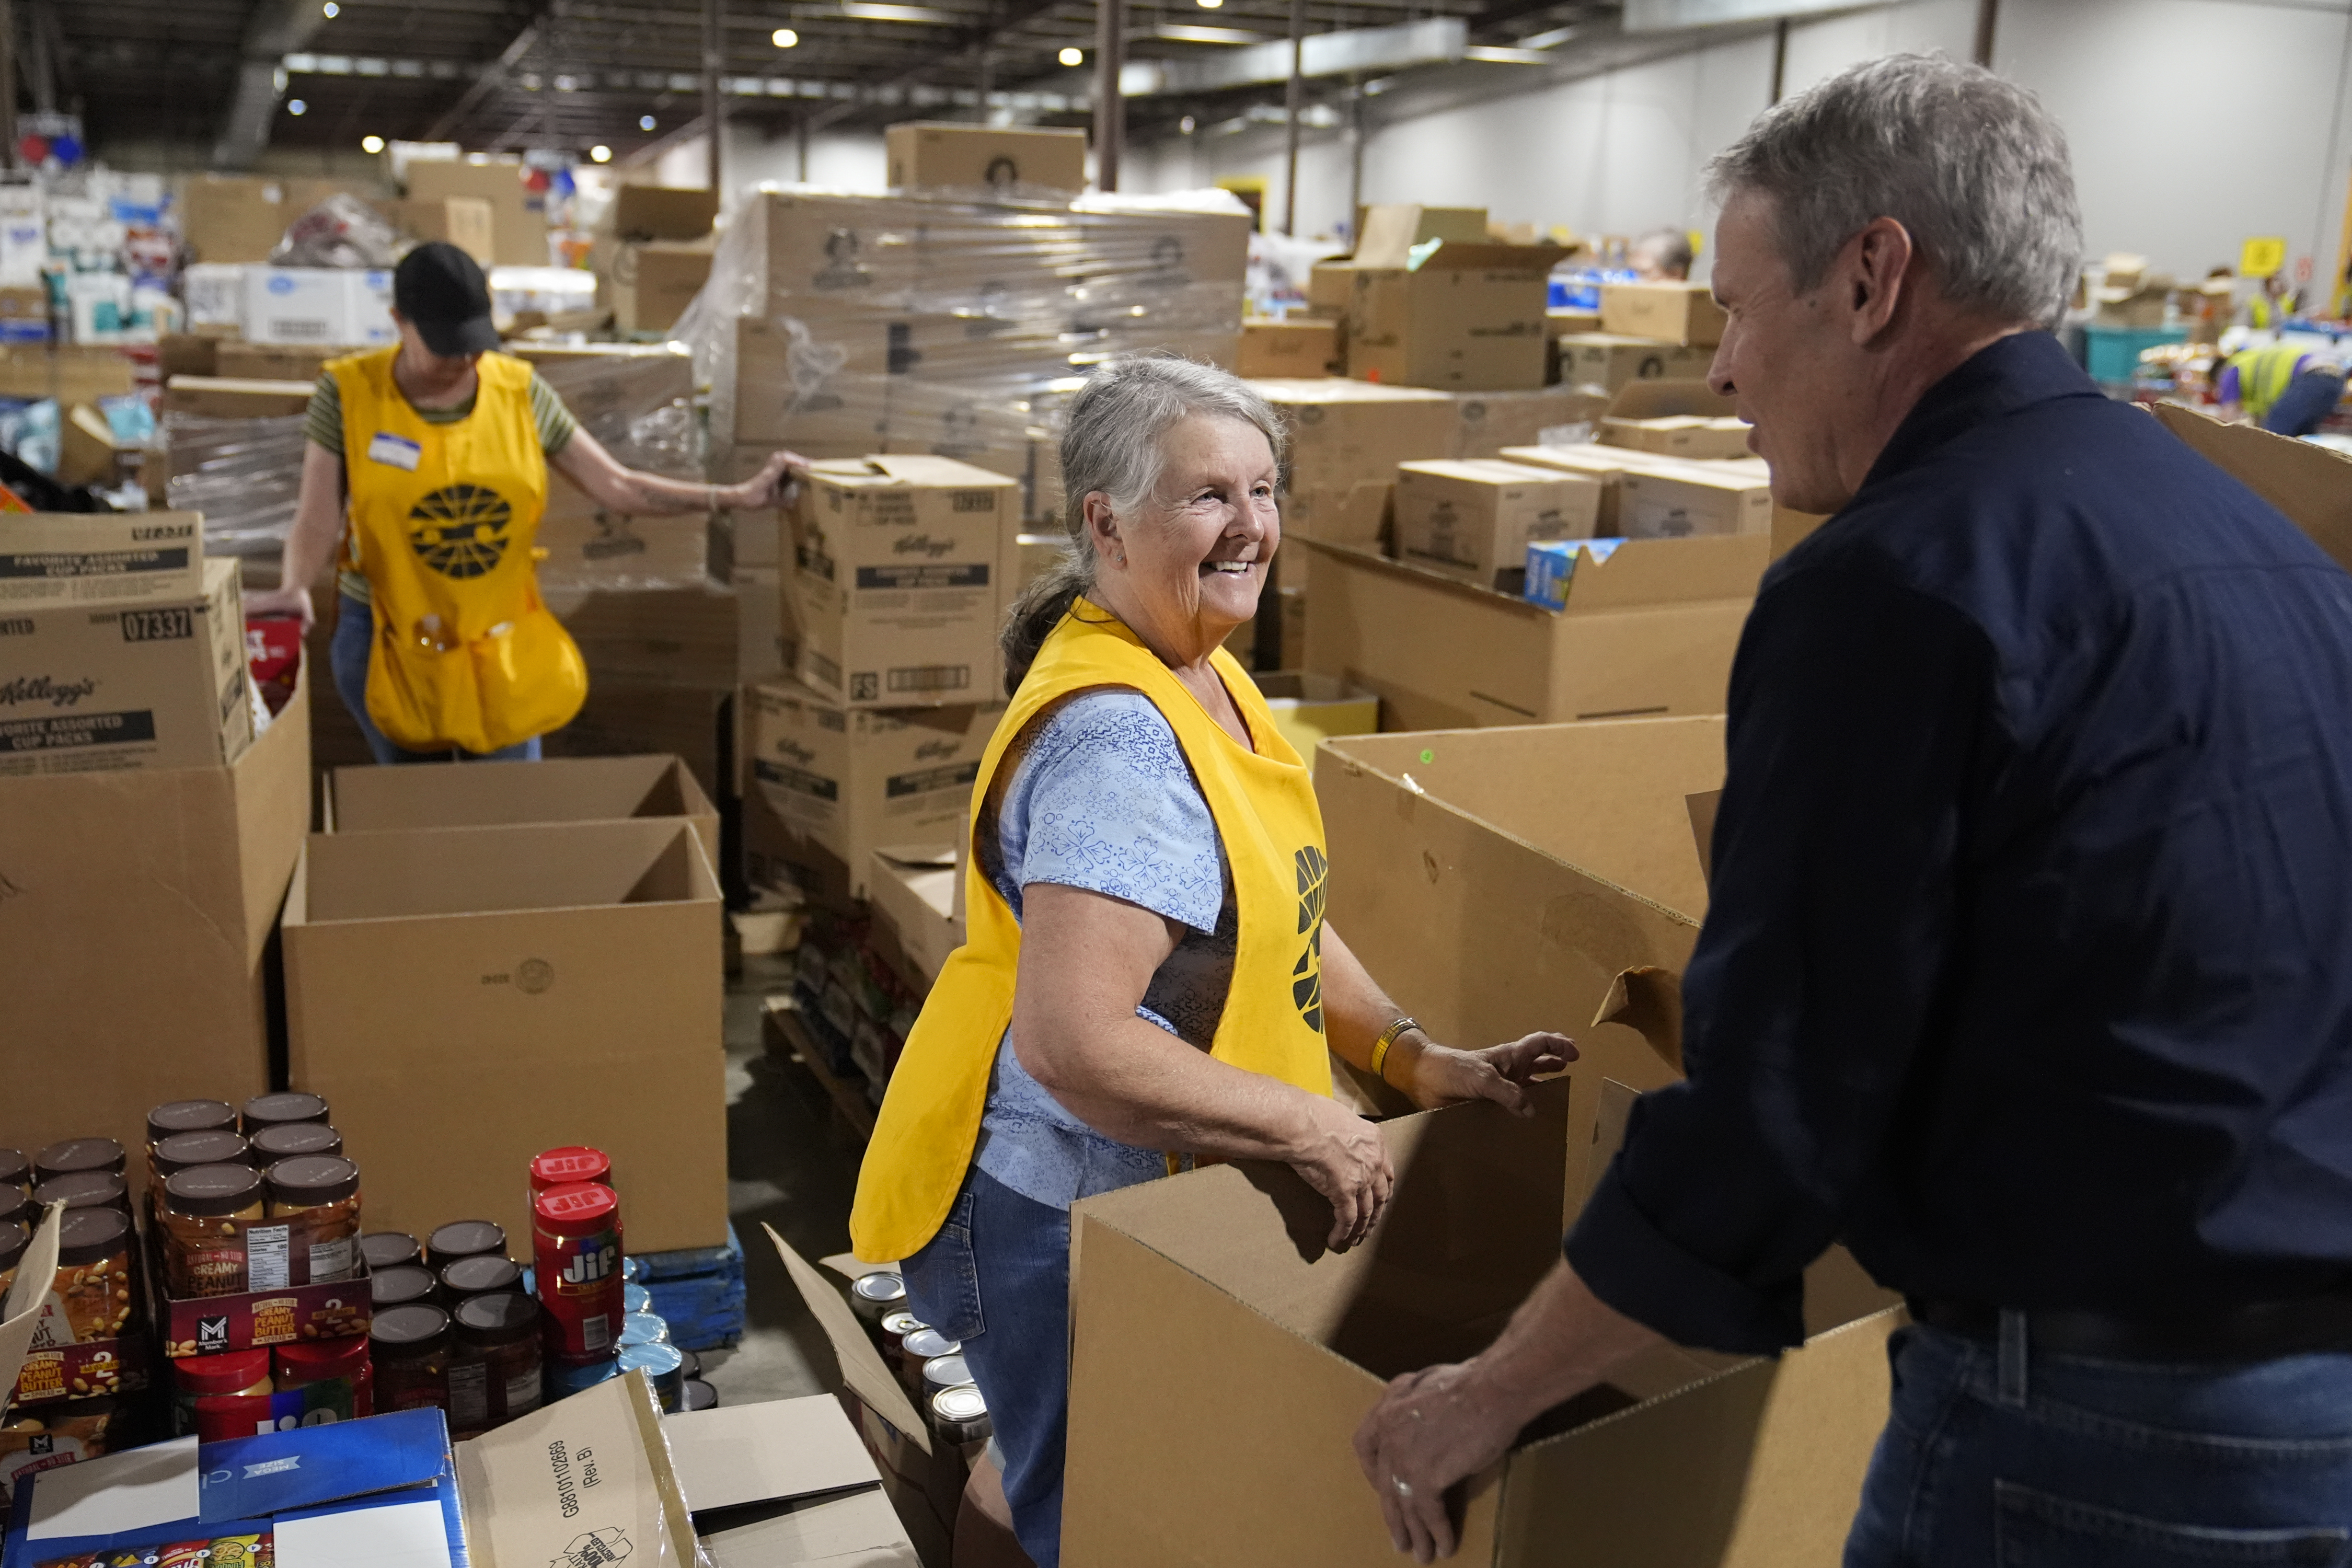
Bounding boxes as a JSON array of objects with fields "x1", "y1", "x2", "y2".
[{"x1": 677, "y1": 186, "x2": 1249, "y2": 517}]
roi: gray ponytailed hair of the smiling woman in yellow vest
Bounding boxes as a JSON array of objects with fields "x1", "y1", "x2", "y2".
[{"x1": 1000, "y1": 355, "x2": 1289, "y2": 696}]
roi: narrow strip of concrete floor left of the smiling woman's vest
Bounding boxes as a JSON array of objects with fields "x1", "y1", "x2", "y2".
[{"x1": 701, "y1": 954, "x2": 863, "y2": 1406}]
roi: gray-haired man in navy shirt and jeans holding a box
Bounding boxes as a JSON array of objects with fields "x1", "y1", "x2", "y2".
[{"x1": 1357, "y1": 56, "x2": 2352, "y2": 1568}]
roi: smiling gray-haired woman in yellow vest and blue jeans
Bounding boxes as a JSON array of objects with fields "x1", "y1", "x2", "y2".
[{"x1": 851, "y1": 358, "x2": 1574, "y2": 1566}]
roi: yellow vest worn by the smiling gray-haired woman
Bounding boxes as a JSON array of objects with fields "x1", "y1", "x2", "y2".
[{"x1": 849, "y1": 599, "x2": 1331, "y2": 1262}]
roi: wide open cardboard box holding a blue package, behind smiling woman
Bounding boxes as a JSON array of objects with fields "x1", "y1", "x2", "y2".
[{"x1": 1303, "y1": 534, "x2": 1771, "y2": 729}]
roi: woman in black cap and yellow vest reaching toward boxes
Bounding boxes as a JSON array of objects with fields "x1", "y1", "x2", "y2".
[{"x1": 245, "y1": 242, "x2": 804, "y2": 762}]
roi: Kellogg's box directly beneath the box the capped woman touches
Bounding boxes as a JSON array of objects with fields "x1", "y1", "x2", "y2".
[{"x1": 743, "y1": 682, "x2": 1005, "y2": 898}]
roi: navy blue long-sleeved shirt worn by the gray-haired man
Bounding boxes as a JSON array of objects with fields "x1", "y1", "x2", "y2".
[{"x1": 1566, "y1": 331, "x2": 2352, "y2": 1352}]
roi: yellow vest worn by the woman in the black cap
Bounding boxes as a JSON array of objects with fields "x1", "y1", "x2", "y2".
[{"x1": 327, "y1": 348, "x2": 588, "y2": 752}]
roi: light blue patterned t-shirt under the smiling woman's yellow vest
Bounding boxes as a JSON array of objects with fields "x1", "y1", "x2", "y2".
[{"x1": 976, "y1": 691, "x2": 1240, "y2": 1208}]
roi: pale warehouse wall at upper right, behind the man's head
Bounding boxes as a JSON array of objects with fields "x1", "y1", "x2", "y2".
[{"x1": 1129, "y1": 0, "x2": 2352, "y2": 287}]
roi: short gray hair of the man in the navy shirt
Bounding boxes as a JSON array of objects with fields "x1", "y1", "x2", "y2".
[{"x1": 1708, "y1": 54, "x2": 2082, "y2": 327}]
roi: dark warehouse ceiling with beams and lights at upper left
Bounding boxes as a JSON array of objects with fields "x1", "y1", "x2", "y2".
[{"x1": 50, "y1": 0, "x2": 1621, "y2": 167}]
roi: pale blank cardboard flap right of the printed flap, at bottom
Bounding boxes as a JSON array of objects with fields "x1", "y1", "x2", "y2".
[{"x1": 661, "y1": 1394, "x2": 882, "y2": 1514}]
